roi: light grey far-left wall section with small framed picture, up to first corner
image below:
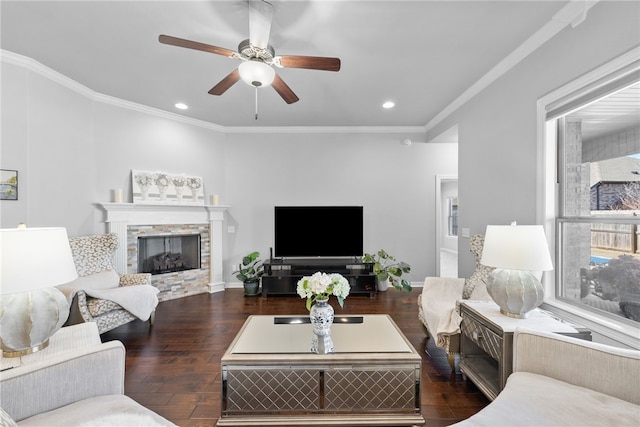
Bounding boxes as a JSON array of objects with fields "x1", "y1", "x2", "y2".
[{"x1": 0, "y1": 63, "x2": 97, "y2": 233}]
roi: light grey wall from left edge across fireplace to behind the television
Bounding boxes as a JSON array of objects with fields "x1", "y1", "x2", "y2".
[{"x1": 0, "y1": 55, "x2": 457, "y2": 283}]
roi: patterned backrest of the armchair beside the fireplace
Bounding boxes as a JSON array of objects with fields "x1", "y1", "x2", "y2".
[{"x1": 69, "y1": 233, "x2": 118, "y2": 277}]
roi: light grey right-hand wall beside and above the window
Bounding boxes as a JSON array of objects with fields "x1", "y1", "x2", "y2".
[{"x1": 428, "y1": 1, "x2": 640, "y2": 277}]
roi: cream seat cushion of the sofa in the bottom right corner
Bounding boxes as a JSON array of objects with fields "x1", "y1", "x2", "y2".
[{"x1": 455, "y1": 372, "x2": 640, "y2": 427}]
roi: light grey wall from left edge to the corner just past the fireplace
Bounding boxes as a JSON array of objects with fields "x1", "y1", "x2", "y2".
[{"x1": 0, "y1": 62, "x2": 225, "y2": 236}]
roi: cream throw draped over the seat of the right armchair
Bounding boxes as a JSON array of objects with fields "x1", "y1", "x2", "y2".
[{"x1": 422, "y1": 277, "x2": 464, "y2": 347}]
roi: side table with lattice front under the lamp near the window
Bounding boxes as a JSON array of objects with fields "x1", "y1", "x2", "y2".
[{"x1": 459, "y1": 301, "x2": 591, "y2": 400}]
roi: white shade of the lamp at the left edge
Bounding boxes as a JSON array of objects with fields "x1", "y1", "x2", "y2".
[{"x1": 0, "y1": 228, "x2": 78, "y2": 294}]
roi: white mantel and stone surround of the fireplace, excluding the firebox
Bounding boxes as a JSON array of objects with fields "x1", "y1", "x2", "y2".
[{"x1": 98, "y1": 203, "x2": 227, "y2": 301}]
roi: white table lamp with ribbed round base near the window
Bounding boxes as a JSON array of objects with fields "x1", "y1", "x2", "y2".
[{"x1": 480, "y1": 223, "x2": 553, "y2": 319}]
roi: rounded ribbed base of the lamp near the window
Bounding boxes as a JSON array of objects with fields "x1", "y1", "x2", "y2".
[{"x1": 487, "y1": 268, "x2": 544, "y2": 319}]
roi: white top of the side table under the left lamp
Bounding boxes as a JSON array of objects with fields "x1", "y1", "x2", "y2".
[{"x1": 0, "y1": 322, "x2": 101, "y2": 371}]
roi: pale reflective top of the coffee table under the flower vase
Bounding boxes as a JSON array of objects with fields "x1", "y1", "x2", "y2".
[{"x1": 230, "y1": 314, "x2": 412, "y2": 354}]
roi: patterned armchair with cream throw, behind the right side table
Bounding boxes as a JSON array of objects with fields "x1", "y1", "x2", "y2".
[{"x1": 418, "y1": 234, "x2": 493, "y2": 369}]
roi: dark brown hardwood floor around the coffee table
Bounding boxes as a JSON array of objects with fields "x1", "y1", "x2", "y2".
[{"x1": 102, "y1": 288, "x2": 489, "y2": 427}]
